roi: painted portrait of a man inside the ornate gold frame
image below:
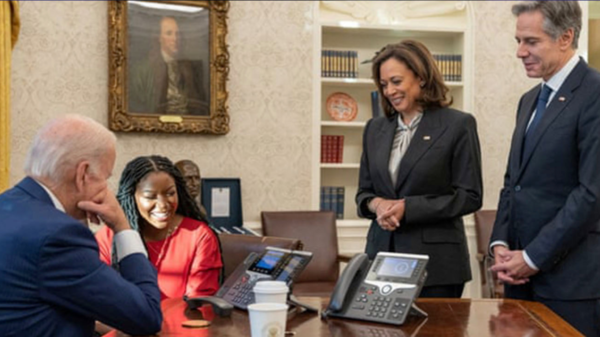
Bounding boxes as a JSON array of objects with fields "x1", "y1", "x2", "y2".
[{"x1": 128, "y1": 1, "x2": 210, "y2": 116}]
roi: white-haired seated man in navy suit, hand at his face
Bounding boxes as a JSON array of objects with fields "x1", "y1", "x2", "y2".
[{"x1": 0, "y1": 115, "x2": 162, "y2": 337}]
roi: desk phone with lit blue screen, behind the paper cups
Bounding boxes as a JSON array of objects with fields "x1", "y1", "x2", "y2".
[{"x1": 216, "y1": 247, "x2": 312, "y2": 309}]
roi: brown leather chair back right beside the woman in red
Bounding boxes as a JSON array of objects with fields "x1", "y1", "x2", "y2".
[{"x1": 219, "y1": 233, "x2": 302, "y2": 279}]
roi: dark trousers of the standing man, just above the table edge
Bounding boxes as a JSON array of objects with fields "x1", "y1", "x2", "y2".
[{"x1": 504, "y1": 283, "x2": 600, "y2": 337}]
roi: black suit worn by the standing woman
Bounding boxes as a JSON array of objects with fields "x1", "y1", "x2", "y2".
[{"x1": 356, "y1": 108, "x2": 483, "y2": 285}]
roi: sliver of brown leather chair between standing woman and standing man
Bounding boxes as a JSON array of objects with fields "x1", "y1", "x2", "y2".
[{"x1": 475, "y1": 210, "x2": 504, "y2": 298}]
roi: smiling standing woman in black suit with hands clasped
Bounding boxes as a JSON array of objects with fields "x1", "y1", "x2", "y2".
[{"x1": 356, "y1": 40, "x2": 483, "y2": 297}]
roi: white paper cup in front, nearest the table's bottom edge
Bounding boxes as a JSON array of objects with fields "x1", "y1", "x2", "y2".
[{"x1": 248, "y1": 303, "x2": 288, "y2": 337}]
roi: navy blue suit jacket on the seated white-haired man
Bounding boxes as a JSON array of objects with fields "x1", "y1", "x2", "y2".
[{"x1": 0, "y1": 178, "x2": 162, "y2": 337}]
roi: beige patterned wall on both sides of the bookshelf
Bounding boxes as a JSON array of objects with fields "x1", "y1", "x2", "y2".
[{"x1": 10, "y1": 1, "x2": 534, "y2": 221}]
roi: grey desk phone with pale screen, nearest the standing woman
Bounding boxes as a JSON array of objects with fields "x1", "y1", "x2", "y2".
[{"x1": 323, "y1": 252, "x2": 429, "y2": 325}]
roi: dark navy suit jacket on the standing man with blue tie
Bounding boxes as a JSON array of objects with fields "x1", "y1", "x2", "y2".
[{"x1": 491, "y1": 60, "x2": 600, "y2": 300}]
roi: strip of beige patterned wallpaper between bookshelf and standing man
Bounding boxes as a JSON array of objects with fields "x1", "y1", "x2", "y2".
[{"x1": 472, "y1": 1, "x2": 538, "y2": 209}]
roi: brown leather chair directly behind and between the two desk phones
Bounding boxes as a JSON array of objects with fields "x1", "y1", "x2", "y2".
[{"x1": 261, "y1": 211, "x2": 350, "y2": 296}]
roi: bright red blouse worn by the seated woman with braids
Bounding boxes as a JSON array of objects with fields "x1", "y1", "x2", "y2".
[{"x1": 96, "y1": 218, "x2": 223, "y2": 299}]
